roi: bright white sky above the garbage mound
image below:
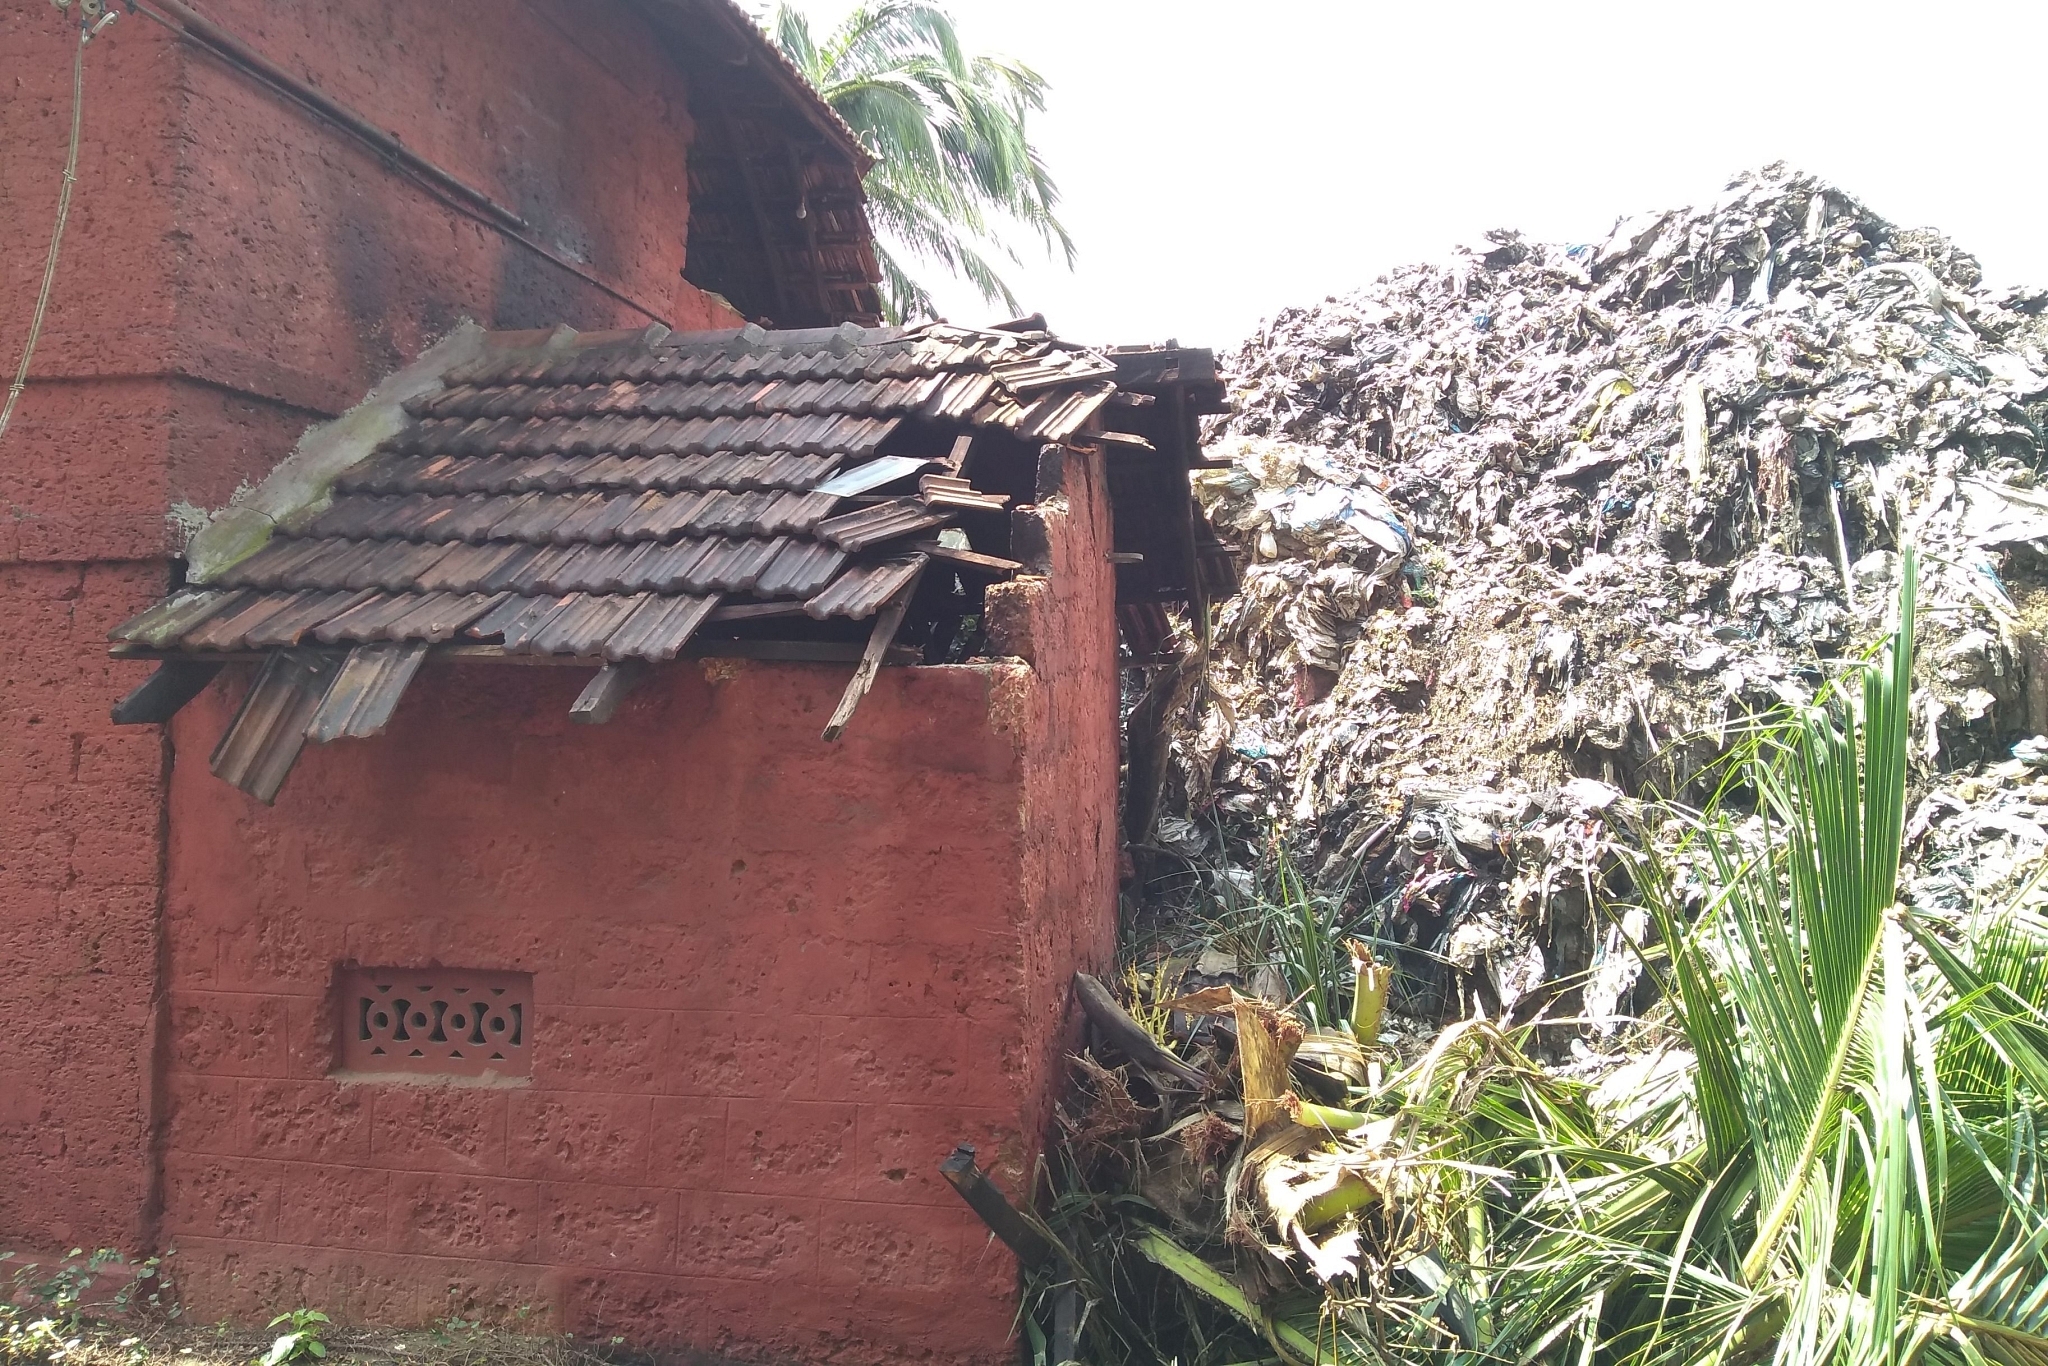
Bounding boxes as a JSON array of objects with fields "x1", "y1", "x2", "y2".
[{"x1": 801, "y1": 0, "x2": 2048, "y2": 348}]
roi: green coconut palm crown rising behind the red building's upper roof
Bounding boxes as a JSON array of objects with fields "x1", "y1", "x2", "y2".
[{"x1": 770, "y1": 0, "x2": 1073, "y2": 322}]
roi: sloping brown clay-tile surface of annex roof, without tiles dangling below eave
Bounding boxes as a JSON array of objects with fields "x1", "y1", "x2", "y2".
[{"x1": 113, "y1": 326, "x2": 1114, "y2": 661}]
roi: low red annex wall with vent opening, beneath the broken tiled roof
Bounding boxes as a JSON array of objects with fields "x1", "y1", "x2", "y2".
[{"x1": 164, "y1": 461, "x2": 1116, "y2": 1362}]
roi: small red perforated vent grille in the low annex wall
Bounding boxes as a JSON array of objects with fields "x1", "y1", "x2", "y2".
[{"x1": 336, "y1": 969, "x2": 532, "y2": 1077}]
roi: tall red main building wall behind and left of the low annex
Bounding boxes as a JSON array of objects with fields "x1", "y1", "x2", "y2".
[{"x1": 0, "y1": 0, "x2": 731, "y2": 1249}]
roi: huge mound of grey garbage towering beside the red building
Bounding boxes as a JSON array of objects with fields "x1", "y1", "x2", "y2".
[{"x1": 1151, "y1": 166, "x2": 2048, "y2": 1018}]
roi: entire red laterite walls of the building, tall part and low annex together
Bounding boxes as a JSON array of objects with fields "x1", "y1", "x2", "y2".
[{"x1": 0, "y1": 0, "x2": 1116, "y2": 1362}]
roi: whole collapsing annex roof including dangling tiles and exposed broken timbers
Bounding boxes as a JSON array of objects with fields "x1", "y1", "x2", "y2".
[{"x1": 113, "y1": 319, "x2": 1196, "y2": 801}]
